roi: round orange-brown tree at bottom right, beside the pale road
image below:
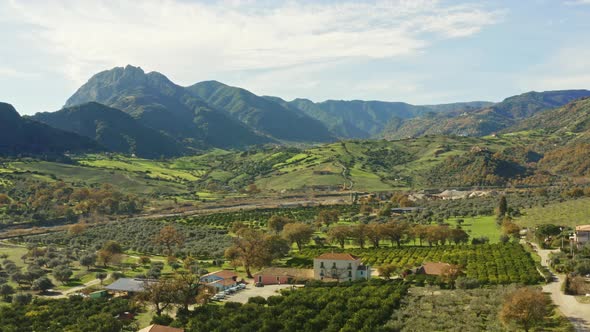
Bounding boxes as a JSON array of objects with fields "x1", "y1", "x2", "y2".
[{"x1": 500, "y1": 287, "x2": 547, "y2": 332}]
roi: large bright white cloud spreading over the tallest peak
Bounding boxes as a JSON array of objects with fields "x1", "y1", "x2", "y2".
[{"x1": 0, "y1": 0, "x2": 502, "y2": 84}]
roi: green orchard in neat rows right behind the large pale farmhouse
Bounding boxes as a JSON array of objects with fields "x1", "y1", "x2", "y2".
[{"x1": 301, "y1": 243, "x2": 543, "y2": 284}]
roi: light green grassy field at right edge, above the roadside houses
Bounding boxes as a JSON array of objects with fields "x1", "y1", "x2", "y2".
[{"x1": 516, "y1": 198, "x2": 590, "y2": 227}]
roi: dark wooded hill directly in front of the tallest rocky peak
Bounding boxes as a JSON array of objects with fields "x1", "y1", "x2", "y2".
[{"x1": 33, "y1": 102, "x2": 187, "y2": 158}]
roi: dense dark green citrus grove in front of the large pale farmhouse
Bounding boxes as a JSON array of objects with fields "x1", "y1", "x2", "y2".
[{"x1": 187, "y1": 280, "x2": 407, "y2": 332}]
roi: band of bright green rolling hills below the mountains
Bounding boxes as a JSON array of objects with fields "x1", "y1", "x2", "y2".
[{"x1": 0, "y1": 135, "x2": 566, "y2": 194}]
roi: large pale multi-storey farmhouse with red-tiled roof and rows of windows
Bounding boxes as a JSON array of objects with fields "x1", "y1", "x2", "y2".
[{"x1": 313, "y1": 253, "x2": 371, "y2": 281}]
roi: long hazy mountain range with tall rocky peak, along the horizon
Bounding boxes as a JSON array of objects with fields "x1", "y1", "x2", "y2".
[{"x1": 0, "y1": 65, "x2": 590, "y2": 158}]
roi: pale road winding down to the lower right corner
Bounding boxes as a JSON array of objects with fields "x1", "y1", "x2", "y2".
[{"x1": 533, "y1": 244, "x2": 590, "y2": 332}]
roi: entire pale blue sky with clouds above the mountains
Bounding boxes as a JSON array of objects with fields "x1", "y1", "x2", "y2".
[{"x1": 0, "y1": 0, "x2": 590, "y2": 114}]
